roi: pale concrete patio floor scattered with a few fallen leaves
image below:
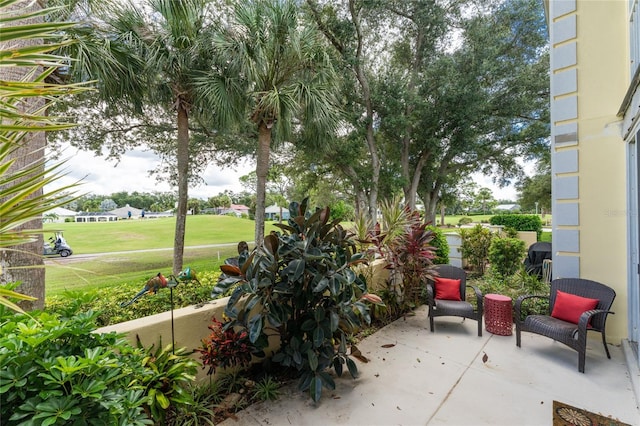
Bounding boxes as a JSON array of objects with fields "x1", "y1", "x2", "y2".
[{"x1": 221, "y1": 307, "x2": 640, "y2": 426}]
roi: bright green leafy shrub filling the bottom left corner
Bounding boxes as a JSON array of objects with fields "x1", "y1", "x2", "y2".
[{"x1": 0, "y1": 312, "x2": 153, "y2": 425}]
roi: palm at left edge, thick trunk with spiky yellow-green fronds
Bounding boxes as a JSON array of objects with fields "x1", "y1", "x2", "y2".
[{"x1": 0, "y1": 0, "x2": 86, "y2": 310}]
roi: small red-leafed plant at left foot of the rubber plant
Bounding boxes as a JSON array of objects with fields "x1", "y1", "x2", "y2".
[{"x1": 196, "y1": 317, "x2": 254, "y2": 374}]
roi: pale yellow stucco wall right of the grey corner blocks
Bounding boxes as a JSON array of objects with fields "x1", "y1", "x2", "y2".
[{"x1": 577, "y1": 1, "x2": 629, "y2": 342}]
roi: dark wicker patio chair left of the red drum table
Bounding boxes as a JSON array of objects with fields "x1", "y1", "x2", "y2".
[{"x1": 427, "y1": 265, "x2": 483, "y2": 336}]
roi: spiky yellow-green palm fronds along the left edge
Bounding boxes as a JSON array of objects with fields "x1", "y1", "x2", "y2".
[{"x1": 0, "y1": 0, "x2": 86, "y2": 312}]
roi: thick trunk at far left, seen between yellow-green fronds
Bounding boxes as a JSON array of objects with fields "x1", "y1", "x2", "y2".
[{"x1": 0, "y1": 1, "x2": 46, "y2": 310}]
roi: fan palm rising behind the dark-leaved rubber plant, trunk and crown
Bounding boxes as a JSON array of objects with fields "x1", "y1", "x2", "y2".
[{"x1": 199, "y1": 0, "x2": 339, "y2": 244}]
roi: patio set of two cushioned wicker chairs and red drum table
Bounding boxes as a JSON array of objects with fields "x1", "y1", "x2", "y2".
[{"x1": 427, "y1": 265, "x2": 616, "y2": 373}]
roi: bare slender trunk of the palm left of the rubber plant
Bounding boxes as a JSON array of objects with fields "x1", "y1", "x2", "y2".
[{"x1": 173, "y1": 102, "x2": 189, "y2": 275}]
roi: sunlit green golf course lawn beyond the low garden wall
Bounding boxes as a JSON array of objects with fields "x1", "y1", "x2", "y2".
[{"x1": 44, "y1": 215, "x2": 275, "y2": 296}]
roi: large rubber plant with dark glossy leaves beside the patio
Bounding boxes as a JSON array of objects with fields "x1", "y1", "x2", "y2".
[{"x1": 218, "y1": 199, "x2": 379, "y2": 401}]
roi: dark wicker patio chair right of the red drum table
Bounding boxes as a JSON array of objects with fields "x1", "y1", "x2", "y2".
[{"x1": 515, "y1": 278, "x2": 616, "y2": 373}]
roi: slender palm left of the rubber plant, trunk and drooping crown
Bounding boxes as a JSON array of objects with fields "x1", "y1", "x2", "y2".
[{"x1": 65, "y1": 0, "x2": 220, "y2": 274}]
